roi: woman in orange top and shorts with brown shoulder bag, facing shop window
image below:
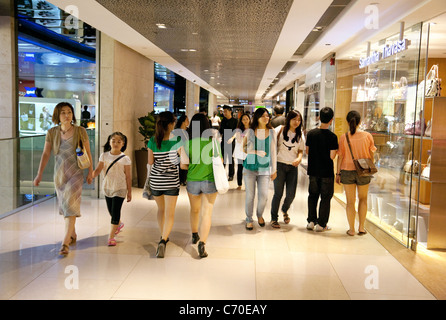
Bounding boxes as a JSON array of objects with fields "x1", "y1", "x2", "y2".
[{"x1": 336, "y1": 110, "x2": 376, "y2": 236}]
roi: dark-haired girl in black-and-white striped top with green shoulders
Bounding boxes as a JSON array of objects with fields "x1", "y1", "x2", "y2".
[{"x1": 147, "y1": 111, "x2": 181, "y2": 258}]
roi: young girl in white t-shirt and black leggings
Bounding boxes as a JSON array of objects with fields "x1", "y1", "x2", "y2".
[{"x1": 93, "y1": 132, "x2": 132, "y2": 246}]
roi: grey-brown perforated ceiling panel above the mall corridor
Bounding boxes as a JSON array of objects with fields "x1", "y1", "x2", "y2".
[{"x1": 97, "y1": 0, "x2": 299, "y2": 100}]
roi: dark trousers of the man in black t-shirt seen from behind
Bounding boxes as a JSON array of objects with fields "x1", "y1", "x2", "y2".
[{"x1": 307, "y1": 176, "x2": 334, "y2": 228}]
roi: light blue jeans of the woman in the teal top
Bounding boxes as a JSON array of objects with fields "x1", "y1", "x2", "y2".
[{"x1": 243, "y1": 169, "x2": 271, "y2": 222}]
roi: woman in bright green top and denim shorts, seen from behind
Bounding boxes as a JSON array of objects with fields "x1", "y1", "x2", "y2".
[{"x1": 181, "y1": 113, "x2": 219, "y2": 258}]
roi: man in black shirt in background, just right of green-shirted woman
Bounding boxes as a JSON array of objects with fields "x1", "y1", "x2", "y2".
[{"x1": 220, "y1": 106, "x2": 237, "y2": 181}]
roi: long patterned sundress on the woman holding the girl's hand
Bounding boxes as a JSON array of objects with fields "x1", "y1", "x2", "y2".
[{"x1": 54, "y1": 137, "x2": 84, "y2": 218}]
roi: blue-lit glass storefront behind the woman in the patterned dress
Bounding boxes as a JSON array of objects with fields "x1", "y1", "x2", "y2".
[{"x1": 12, "y1": 0, "x2": 98, "y2": 209}]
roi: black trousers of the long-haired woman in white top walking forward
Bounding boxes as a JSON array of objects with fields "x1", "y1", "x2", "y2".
[{"x1": 271, "y1": 162, "x2": 297, "y2": 221}]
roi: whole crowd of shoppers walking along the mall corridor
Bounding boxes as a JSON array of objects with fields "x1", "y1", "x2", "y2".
[{"x1": 34, "y1": 102, "x2": 376, "y2": 258}]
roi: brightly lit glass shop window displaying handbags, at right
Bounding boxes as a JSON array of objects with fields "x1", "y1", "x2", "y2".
[{"x1": 335, "y1": 24, "x2": 427, "y2": 246}]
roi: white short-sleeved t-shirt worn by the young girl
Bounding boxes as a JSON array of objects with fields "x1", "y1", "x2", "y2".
[{"x1": 99, "y1": 151, "x2": 132, "y2": 198}]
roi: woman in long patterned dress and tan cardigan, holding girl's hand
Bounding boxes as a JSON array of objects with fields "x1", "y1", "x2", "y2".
[{"x1": 34, "y1": 102, "x2": 93, "y2": 255}]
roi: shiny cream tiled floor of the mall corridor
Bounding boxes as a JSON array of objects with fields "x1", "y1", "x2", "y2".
[{"x1": 0, "y1": 176, "x2": 435, "y2": 300}]
